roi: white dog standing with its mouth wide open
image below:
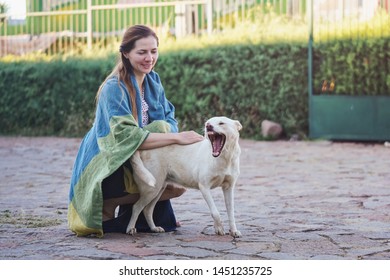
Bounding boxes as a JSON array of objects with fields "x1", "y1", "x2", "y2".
[{"x1": 126, "y1": 116, "x2": 242, "y2": 238}]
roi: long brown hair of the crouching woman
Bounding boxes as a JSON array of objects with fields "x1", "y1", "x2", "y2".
[{"x1": 96, "y1": 25, "x2": 159, "y2": 122}]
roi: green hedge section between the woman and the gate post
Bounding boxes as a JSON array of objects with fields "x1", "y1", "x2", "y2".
[{"x1": 158, "y1": 45, "x2": 307, "y2": 138}]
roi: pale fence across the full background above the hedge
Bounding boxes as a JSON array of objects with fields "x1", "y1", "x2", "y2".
[{"x1": 0, "y1": 0, "x2": 390, "y2": 56}]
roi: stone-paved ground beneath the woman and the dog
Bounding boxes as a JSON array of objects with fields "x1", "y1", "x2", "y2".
[{"x1": 0, "y1": 137, "x2": 390, "y2": 260}]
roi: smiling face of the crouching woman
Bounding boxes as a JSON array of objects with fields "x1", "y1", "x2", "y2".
[{"x1": 125, "y1": 36, "x2": 158, "y2": 75}]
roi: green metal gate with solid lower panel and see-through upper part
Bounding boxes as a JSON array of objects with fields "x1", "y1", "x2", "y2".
[{"x1": 308, "y1": 0, "x2": 390, "y2": 141}]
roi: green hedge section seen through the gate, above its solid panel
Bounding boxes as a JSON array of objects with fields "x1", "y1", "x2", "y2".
[{"x1": 313, "y1": 38, "x2": 390, "y2": 96}]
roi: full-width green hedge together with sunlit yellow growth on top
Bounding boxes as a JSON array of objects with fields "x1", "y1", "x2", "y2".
[{"x1": 0, "y1": 0, "x2": 390, "y2": 139}]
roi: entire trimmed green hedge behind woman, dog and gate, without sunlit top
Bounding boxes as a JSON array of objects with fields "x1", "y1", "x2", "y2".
[{"x1": 0, "y1": 40, "x2": 390, "y2": 139}]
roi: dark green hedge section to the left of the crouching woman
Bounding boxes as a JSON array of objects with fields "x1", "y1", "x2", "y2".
[{"x1": 0, "y1": 57, "x2": 112, "y2": 136}]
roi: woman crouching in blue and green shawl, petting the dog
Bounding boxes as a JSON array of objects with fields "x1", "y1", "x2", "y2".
[{"x1": 68, "y1": 25, "x2": 203, "y2": 236}]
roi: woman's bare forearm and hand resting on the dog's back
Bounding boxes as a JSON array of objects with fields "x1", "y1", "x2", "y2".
[{"x1": 139, "y1": 131, "x2": 204, "y2": 150}]
